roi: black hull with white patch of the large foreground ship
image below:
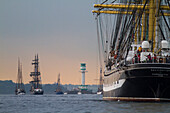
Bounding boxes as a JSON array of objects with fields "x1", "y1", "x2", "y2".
[{"x1": 103, "y1": 63, "x2": 170, "y2": 101}]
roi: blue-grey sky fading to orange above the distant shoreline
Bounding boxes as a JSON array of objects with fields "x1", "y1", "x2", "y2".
[{"x1": 0, "y1": 0, "x2": 99, "y2": 84}]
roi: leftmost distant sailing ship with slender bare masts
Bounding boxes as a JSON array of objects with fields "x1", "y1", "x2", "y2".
[{"x1": 15, "y1": 59, "x2": 26, "y2": 95}]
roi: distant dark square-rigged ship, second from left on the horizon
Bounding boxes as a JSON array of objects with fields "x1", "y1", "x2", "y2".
[{"x1": 30, "y1": 54, "x2": 44, "y2": 95}]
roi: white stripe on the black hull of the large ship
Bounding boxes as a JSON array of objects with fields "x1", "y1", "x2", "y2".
[{"x1": 103, "y1": 79, "x2": 126, "y2": 92}]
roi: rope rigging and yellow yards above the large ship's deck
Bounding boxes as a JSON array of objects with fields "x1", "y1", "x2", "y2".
[{"x1": 95, "y1": 0, "x2": 170, "y2": 68}]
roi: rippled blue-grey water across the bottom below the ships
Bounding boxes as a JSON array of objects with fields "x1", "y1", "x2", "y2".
[{"x1": 0, "y1": 94, "x2": 170, "y2": 113}]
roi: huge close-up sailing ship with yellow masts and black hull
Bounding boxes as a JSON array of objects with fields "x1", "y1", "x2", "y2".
[{"x1": 92, "y1": 0, "x2": 170, "y2": 101}]
